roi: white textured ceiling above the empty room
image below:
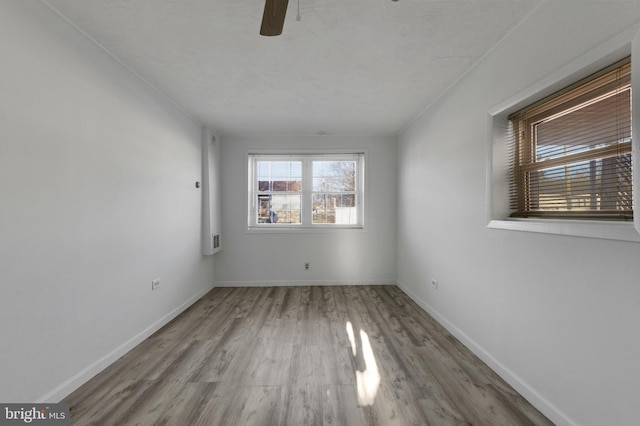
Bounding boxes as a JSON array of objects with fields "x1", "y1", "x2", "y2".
[{"x1": 43, "y1": 0, "x2": 538, "y2": 134}]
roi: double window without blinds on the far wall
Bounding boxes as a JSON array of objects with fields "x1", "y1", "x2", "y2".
[{"x1": 248, "y1": 153, "x2": 364, "y2": 229}]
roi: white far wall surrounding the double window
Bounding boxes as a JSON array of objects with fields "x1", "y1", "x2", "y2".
[{"x1": 215, "y1": 136, "x2": 396, "y2": 286}]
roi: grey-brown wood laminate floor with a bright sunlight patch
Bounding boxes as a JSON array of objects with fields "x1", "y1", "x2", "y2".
[{"x1": 64, "y1": 286, "x2": 552, "y2": 426}]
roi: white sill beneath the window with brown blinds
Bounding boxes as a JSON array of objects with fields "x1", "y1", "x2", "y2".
[{"x1": 487, "y1": 219, "x2": 640, "y2": 242}]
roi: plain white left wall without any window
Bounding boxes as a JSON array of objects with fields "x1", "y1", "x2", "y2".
[{"x1": 0, "y1": 0, "x2": 213, "y2": 402}]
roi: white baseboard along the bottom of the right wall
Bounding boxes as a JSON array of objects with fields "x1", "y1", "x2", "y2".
[{"x1": 397, "y1": 283, "x2": 577, "y2": 426}]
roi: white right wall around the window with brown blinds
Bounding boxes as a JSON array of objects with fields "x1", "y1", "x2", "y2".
[{"x1": 398, "y1": 1, "x2": 640, "y2": 425}]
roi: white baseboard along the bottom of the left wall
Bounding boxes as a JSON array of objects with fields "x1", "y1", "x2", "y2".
[{"x1": 36, "y1": 285, "x2": 214, "y2": 403}]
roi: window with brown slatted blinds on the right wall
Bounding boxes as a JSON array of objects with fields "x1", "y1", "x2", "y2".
[{"x1": 508, "y1": 58, "x2": 633, "y2": 220}]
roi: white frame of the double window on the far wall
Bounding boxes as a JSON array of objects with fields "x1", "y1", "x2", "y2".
[{"x1": 245, "y1": 150, "x2": 367, "y2": 232}]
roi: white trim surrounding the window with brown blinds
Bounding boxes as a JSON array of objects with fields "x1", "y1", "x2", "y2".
[{"x1": 486, "y1": 26, "x2": 640, "y2": 242}]
